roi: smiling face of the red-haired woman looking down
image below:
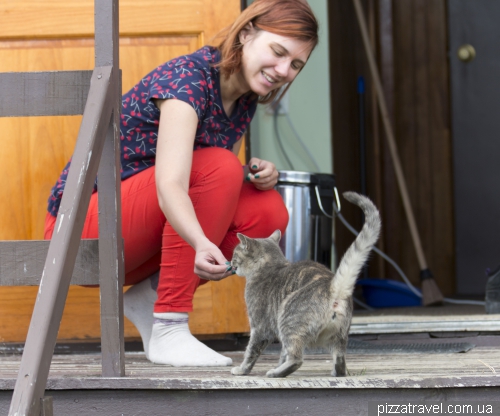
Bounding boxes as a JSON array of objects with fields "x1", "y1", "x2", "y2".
[{"x1": 240, "y1": 27, "x2": 311, "y2": 96}]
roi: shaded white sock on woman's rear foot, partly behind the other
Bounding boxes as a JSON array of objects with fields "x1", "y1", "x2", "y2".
[{"x1": 123, "y1": 272, "x2": 160, "y2": 358}]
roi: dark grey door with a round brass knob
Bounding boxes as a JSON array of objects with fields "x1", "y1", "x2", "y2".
[{"x1": 448, "y1": 0, "x2": 500, "y2": 295}]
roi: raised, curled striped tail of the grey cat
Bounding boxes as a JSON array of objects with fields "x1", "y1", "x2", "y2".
[{"x1": 332, "y1": 192, "x2": 381, "y2": 299}]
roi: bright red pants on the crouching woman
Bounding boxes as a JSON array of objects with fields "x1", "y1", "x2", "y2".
[{"x1": 44, "y1": 147, "x2": 288, "y2": 312}]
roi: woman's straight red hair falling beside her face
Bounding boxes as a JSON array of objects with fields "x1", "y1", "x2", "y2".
[{"x1": 213, "y1": 0, "x2": 318, "y2": 104}]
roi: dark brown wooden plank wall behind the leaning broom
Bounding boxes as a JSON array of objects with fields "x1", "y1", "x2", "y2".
[{"x1": 329, "y1": 0, "x2": 455, "y2": 295}]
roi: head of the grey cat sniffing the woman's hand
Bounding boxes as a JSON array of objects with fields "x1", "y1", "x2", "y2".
[{"x1": 231, "y1": 230, "x2": 286, "y2": 278}]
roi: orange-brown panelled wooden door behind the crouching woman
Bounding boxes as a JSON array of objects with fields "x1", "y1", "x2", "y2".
[{"x1": 0, "y1": 0, "x2": 249, "y2": 342}]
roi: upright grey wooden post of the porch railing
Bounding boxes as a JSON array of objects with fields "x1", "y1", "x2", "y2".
[{"x1": 95, "y1": 0, "x2": 125, "y2": 377}]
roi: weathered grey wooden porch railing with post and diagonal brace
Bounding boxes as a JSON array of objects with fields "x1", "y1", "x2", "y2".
[{"x1": 0, "y1": 0, "x2": 125, "y2": 416}]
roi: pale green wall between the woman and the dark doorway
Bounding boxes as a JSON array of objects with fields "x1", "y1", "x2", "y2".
[{"x1": 251, "y1": 0, "x2": 333, "y2": 173}]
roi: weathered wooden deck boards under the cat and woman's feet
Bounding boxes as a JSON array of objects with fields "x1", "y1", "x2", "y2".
[{"x1": 0, "y1": 347, "x2": 500, "y2": 390}]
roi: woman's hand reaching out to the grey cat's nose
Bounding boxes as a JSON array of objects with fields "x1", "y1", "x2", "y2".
[{"x1": 194, "y1": 240, "x2": 234, "y2": 281}]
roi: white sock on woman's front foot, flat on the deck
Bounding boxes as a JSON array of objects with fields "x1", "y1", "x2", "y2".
[{"x1": 149, "y1": 312, "x2": 233, "y2": 367}]
